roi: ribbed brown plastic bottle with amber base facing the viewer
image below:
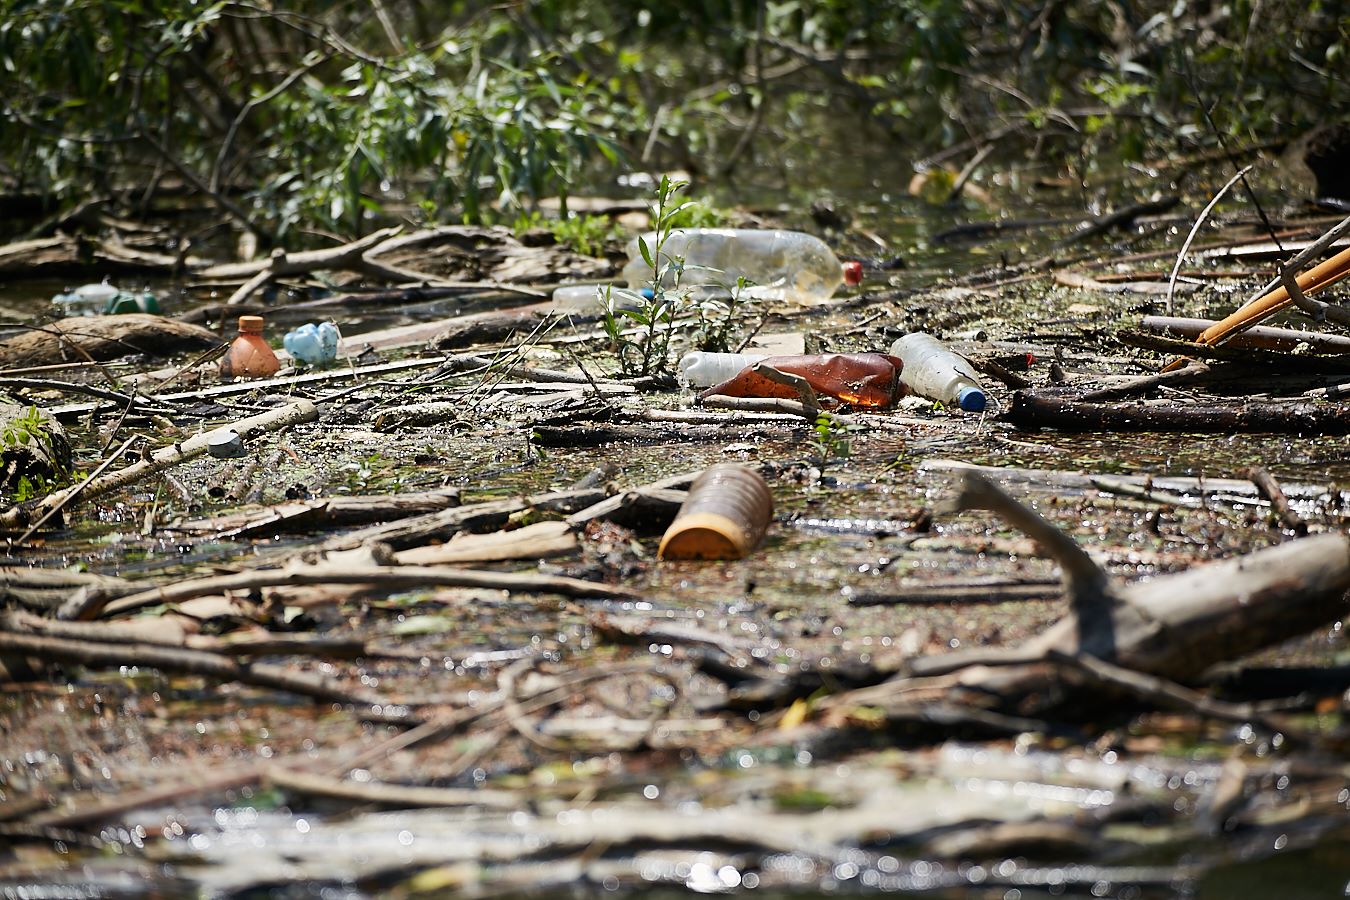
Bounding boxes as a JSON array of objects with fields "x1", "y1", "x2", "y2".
[{"x1": 657, "y1": 463, "x2": 774, "y2": 560}]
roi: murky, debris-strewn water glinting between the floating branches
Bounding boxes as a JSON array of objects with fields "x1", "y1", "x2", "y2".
[{"x1": 0, "y1": 170, "x2": 1350, "y2": 900}]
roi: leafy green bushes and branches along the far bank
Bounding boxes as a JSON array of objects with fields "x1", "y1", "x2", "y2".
[{"x1": 0, "y1": 0, "x2": 1350, "y2": 243}]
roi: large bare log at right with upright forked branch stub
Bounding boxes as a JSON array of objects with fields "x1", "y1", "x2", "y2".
[{"x1": 819, "y1": 472, "x2": 1350, "y2": 729}]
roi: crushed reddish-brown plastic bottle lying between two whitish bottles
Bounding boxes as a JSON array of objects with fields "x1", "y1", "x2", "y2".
[{"x1": 701, "y1": 354, "x2": 905, "y2": 409}]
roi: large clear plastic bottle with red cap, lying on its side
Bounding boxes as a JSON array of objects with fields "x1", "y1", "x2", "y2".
[{"x1": 624, "y1": 228, "x2": 863, "y2": 302}]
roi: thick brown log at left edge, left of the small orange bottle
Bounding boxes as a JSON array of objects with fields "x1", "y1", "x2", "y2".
[{"x1": 0, "y1": 313, "x2": 221, "y2": 368}]
